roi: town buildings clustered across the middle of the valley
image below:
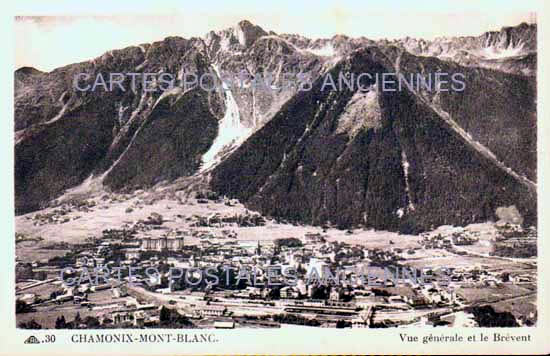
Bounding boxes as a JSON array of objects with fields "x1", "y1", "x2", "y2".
[{"x1": 14, "y1": 207, "x2": 535, "y2": 328}]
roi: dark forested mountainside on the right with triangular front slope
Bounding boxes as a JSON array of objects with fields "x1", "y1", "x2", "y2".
[{"x1": 212, "y1": 47, "x2": 536, "y2": 229}]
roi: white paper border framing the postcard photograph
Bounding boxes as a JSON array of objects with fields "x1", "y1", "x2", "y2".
[{"x1": 0, "y1": 0, "x2": 550, "y2": 355}]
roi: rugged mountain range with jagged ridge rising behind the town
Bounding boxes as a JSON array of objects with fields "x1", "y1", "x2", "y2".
[{"x1": 14, "y1": 21, "x2": 537, "y2": 232}]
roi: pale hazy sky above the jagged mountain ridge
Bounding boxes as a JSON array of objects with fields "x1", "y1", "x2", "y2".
[{"x1": 14, "y1": 0, "x2": 536, "y2": 71}]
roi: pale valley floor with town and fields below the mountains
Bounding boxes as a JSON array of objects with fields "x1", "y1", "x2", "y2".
[{"x1": 16, "y1": 188, "x2": 537, "y2": 328}]
